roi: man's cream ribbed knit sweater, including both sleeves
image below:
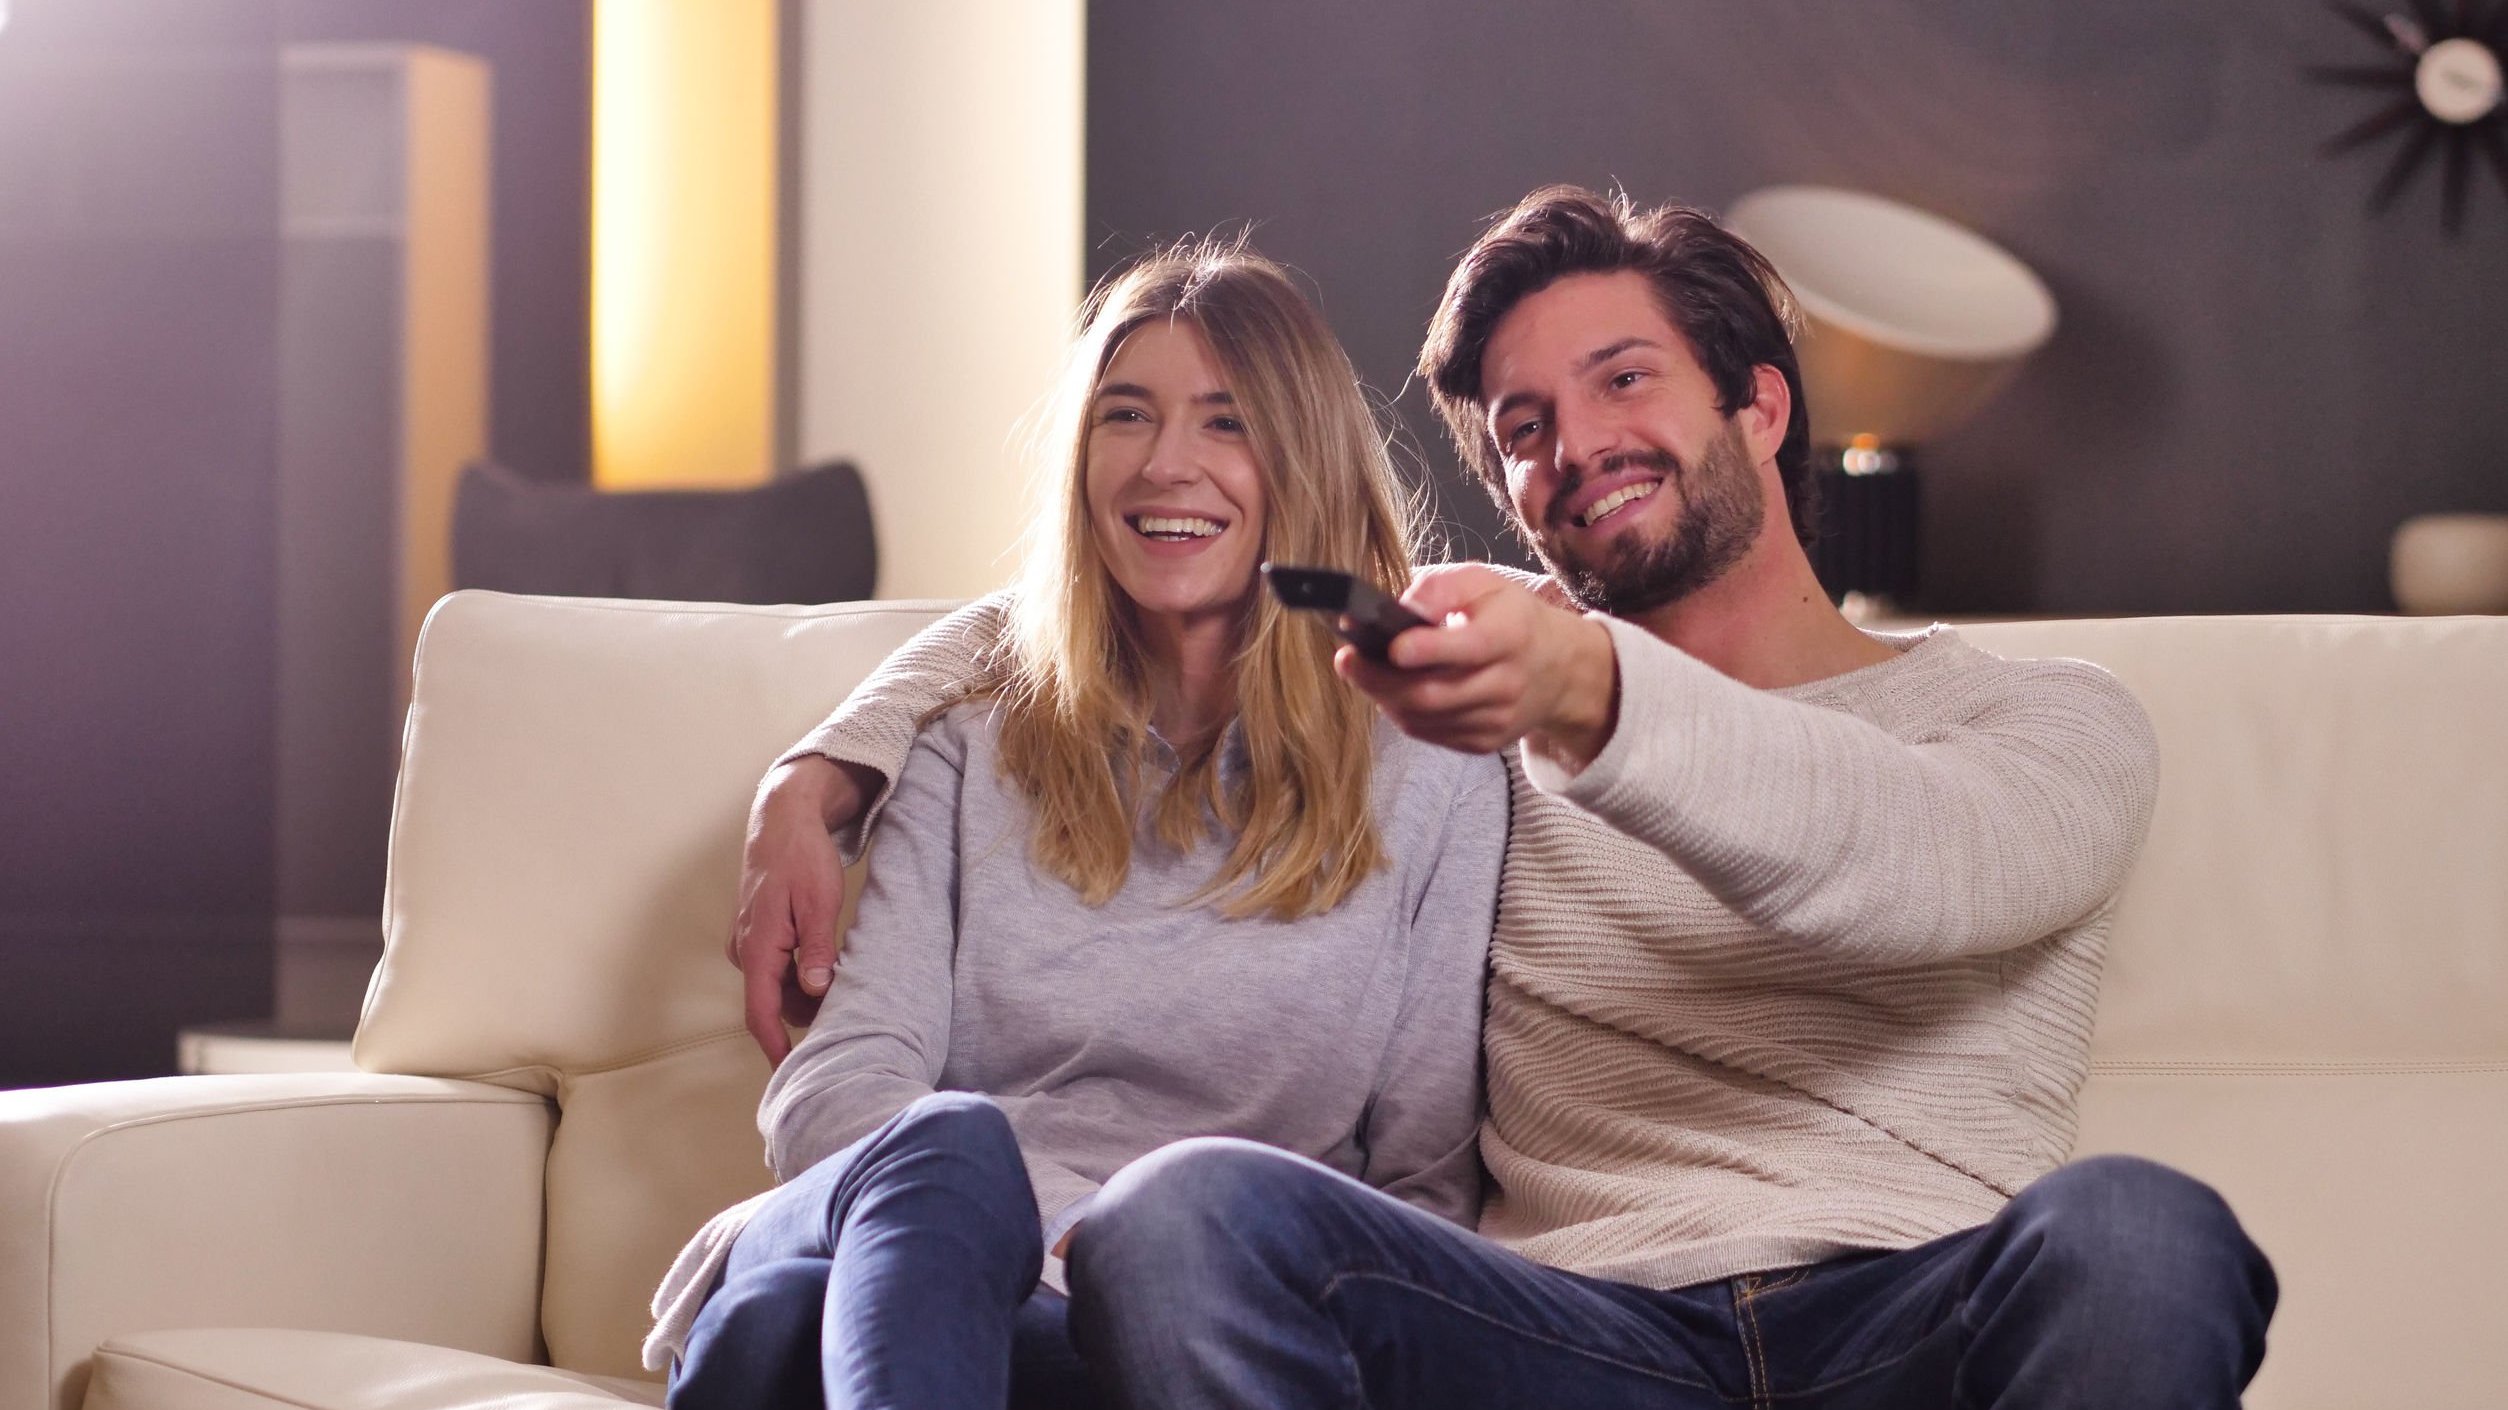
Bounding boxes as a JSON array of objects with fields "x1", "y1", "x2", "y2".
[{"x1": 793, "y1": 597, "x2": 2157, "y2": 1287}]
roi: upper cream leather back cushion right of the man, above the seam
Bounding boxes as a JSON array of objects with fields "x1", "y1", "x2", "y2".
[{"x1": 1961, "y1": 617, "x2": 2508, "y2": 1064}]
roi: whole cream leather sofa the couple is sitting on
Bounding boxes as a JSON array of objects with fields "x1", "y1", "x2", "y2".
[{"x1": 0, "y1": 592, "x2": 2508, "y2": 1410}]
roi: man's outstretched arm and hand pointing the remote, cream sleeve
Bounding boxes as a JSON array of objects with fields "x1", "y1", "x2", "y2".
[{"x1": 1337, "y1": 565, "x2": 2157, "y2": 963}]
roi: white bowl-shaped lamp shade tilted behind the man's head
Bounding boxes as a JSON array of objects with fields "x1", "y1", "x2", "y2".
[{"x1": 1726, "y1": 186, "x2": 2054, "y2": 447}]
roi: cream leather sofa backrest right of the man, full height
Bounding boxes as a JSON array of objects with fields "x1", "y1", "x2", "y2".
[{"x1": 1961, "y1": 617, "x2": 2508, "y2": 1410}]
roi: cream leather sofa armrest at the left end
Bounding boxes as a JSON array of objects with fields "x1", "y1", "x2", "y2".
[{"x1": 0, "y1": 1074, "x2": 554, "y2": 1410}]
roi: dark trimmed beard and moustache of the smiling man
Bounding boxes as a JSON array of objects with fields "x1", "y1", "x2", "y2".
[{"x1": 1532, "y1": 421, "x2": 1768, "y2": 617}]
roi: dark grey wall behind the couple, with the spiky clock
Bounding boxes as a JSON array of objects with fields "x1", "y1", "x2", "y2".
[{"x1": 1088, "y1": 0, "x2": 2508, "y2": 612}]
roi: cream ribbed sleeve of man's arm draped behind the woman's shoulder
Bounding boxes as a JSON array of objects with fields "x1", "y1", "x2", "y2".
[{"x1": 775, "y1": 592, "x2": 1011, "y2": 863}]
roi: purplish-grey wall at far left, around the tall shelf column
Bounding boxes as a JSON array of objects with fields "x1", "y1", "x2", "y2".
[{"x1": 0, "y1": 0, "x2": 589, "y2": 1086}]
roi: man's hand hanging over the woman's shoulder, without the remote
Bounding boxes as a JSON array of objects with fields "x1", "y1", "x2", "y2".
[{"x1": 727, "y1": 755, "x2": 878, "y2": 1064}]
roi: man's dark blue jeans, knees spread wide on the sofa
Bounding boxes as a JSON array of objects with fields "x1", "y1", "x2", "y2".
[{"x1": 1071, "y1": 1139, "x2": 2275, "y2": 1410}]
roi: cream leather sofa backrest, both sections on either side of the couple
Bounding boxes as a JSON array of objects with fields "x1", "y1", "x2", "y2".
[{"x1": 356, "y1": 592, "x2": 2508, "y2": 1410}]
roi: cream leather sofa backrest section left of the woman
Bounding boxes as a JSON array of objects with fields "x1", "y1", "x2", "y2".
[{"x1": 356, "y1": 592, "x2": 938, "y2": 1375}]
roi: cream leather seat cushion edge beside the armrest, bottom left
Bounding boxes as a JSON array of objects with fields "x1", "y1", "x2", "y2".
[{"x1": 88, "y1": 1327, "x2": 662, "y2": 1410}]
